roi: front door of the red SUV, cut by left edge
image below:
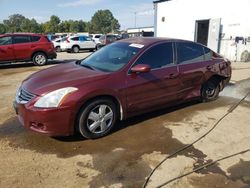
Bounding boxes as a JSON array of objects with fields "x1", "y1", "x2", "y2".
[{"x1": 0, "y1": 36, "x2": 15, "y2": 61}]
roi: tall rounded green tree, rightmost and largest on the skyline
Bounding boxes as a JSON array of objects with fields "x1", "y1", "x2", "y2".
[{"x1": 89, "y1": 10, "x2": 120, "y2": 33}]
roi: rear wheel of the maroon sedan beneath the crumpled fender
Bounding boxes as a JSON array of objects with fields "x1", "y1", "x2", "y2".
[{"x1": 201, "y1": 80, "x2": 220, "y2": 102}]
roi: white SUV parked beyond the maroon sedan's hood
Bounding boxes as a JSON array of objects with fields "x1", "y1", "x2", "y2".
[{"x1": 61, "y1": 36, "x2": 96, "y2": 53}]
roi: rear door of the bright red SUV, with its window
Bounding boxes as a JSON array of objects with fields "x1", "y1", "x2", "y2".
[{"x1": 13, "y1": 35, "x2": 32, "y2": 60}]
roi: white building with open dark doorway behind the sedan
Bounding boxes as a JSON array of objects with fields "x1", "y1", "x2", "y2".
[{"x1": 154, "y1": 0, "x2": 250, "y2": 61}]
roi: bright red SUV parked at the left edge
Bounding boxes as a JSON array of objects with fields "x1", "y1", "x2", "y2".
[{"x1": 0, "y1": 33, "x2": 57, "y2": 66}]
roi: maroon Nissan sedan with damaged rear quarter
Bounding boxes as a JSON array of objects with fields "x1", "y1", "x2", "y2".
[{"x1": 14, "y1": 38, "x2": 231, "y2": 138}]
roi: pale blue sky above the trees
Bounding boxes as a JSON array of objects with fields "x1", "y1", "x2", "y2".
[{"x1": 0, "y1": 0, "x2": 154, "y2": 29}]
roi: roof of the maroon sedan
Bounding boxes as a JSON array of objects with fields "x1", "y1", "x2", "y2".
[{"x1": 121, "y1": 37, "x2": 189, "y2": 45}]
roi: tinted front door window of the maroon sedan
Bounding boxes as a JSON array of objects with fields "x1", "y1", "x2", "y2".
[{"x1": 133, "y1": 42, "x2": 173, "y2": 69}]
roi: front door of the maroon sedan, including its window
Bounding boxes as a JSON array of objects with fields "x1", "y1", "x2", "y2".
[{"x1": 126, "y1": 42, "x2": 180, "y2": 114}]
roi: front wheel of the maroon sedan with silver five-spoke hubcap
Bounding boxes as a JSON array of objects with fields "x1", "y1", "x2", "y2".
[{"x1": 76, "y1": 98, "x2": 118, "y2": 139}]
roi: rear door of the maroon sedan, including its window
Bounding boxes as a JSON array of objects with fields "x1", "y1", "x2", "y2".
[{"x1": 176, "y1": 42, "x2": 206, "y2": 98}]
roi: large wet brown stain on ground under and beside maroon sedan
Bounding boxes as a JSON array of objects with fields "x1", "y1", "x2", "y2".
[{"x1": 0, "y1": 97, "x2": 242, "y2": 187}]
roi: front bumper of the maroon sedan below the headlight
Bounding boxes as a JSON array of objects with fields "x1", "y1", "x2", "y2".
[{"x1": 13, "y1": 101, "x2": 74, "y2": 136}]
